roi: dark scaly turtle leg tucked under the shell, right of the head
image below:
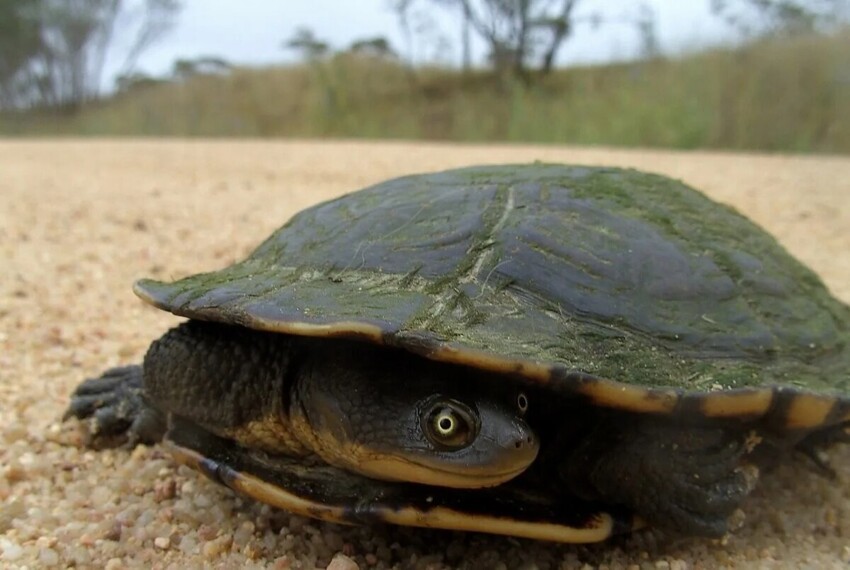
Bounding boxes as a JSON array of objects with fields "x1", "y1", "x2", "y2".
[{"x1": 561, "y1": 418, "x2": 758, "y2": 537}]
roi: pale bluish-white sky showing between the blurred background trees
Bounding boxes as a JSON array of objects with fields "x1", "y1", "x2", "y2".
[{"x1": 107, "y1": 0, "x2": 733, "y2": 83}]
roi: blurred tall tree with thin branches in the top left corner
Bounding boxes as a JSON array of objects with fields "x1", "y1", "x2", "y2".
[{"x1": 0, "y1": 0, "x2": 180, "y2": 109}]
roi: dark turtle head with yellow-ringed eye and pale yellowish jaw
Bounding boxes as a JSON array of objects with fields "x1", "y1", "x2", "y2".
[{"x1": 290, "y1": 343, "x2": 539, "y2": 488}]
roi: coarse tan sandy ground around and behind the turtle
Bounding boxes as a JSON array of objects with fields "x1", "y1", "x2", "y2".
[{"x1": 0, "y1": 141, "x2": 850, "y2": 570}]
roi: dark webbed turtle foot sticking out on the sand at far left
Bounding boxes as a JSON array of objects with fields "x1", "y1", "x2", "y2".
[{"x1": 64, "y1": 365, "x2": 166, "y2": 447}]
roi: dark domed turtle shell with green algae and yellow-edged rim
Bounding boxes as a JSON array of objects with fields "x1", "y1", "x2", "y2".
[{"x1": 135, "y1": 164, "x2": 850, "y2": 430}]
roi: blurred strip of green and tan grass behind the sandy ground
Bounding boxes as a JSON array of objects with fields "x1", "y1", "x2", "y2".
[{"x1": 0, "y1": 30, "x2": 850, "y2": 153}]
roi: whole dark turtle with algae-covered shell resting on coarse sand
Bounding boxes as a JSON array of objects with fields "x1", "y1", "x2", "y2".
[{"x1": 66, "y1": 163, "x2": 850, "y2": 543}]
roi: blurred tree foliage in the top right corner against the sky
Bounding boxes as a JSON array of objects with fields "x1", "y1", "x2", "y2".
[{"x1": 710, "y1": 0, "x2": 850, "y2": 38}]
